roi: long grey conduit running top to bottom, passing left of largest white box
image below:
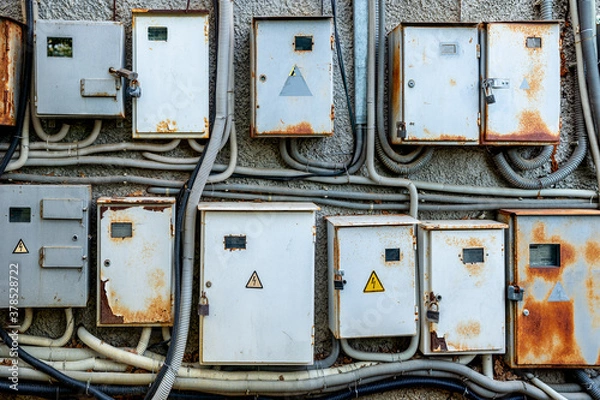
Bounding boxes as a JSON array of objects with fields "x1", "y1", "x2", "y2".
[{"x1": 152, "y1": 0, "x2": 234, "y2": 400}]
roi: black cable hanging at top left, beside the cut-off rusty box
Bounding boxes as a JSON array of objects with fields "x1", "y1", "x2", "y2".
[{"x1": 0, "y1": 0, "x2": 34, "y2": 176}]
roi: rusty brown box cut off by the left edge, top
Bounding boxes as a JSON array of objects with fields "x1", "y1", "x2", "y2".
[{"x1": 0, "y1": 17, "x2": 23, "y2": 126}]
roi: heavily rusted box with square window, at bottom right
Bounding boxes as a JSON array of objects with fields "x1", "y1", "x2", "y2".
[{"x1": 499, "y1": 210, "x2": 600, "y2": 368}]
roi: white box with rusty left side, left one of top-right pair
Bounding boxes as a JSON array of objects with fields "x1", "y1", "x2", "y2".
[{"x1": 389, "y1": 24, "x2": 479, "y2": 145}]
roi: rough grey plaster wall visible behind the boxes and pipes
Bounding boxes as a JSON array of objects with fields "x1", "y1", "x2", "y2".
[{"x1": 0, "y1": 0, "x2": 595, "y2": 400}]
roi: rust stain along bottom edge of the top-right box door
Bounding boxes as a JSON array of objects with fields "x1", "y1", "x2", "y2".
[{"x1": 484, "y1": 110, "x2": 559, "y2": 144}]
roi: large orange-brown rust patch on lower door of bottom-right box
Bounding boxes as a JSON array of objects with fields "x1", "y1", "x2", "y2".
[{"x1": 517, "y1": 299, "x2": 586, "y2": 365}]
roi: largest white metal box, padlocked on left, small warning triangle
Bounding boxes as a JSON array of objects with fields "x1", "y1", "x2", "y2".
[{"x1": 198, "y1": 203, "x2": 318, "y2": 365}]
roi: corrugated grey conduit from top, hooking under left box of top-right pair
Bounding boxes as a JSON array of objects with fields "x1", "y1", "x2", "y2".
[{"x1": 375, "y1": 0, "x2": 434, "y2": 169}]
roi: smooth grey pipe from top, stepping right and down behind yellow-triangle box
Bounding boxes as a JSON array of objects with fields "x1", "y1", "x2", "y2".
[{"x1": 366, "y1": 1, "x2": 419, "y2": 218}]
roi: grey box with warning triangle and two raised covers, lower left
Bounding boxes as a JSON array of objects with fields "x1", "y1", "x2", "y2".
[{"x1": 0, "y1": 185, "x2": 91, "y2": 308}]
